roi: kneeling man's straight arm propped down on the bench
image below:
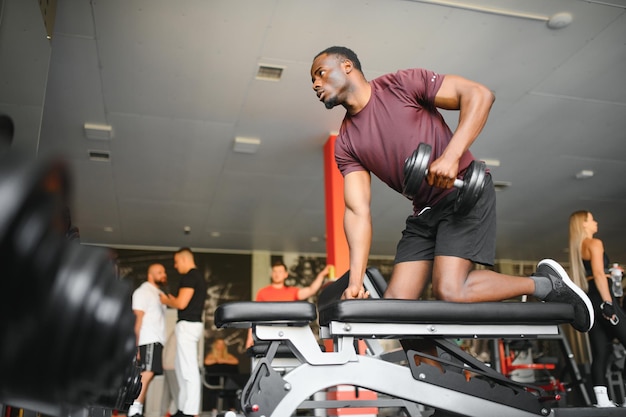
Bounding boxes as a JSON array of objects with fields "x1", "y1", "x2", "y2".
[{"x1": 343, "y1": 171, "x2": 372, "y2": 298}]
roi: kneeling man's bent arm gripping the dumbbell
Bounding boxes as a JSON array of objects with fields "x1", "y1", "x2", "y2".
[{"x1": 427, "y1": 75, "x2": 495, "y2": 188}]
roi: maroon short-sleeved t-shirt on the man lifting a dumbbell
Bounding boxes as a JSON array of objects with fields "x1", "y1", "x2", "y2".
[{"x1": 335, "y1": 69, "x2": 474, "y2": 212}]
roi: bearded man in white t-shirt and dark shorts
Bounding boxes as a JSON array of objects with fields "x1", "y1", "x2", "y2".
[{"x1": 128, "y1": 264, "x2": 167, "y2": 417}]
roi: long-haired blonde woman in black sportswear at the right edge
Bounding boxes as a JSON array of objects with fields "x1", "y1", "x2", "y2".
[{"x1": 569, "y1": 210, "x2": 626, "y2": 407}]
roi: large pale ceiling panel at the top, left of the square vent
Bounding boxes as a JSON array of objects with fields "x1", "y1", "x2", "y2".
[{"x1": 96, "y1": 1, "x2": 271, "y2": 122}]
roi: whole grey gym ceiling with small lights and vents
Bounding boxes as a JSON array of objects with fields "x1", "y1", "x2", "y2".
[{"x1": 0, "y1": 0, "x2": 626, "y2": 263}]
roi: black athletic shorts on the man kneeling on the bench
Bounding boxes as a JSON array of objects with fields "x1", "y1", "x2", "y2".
[{"x1": 394, "y1": 174, "x2": 496, "y2": 266}]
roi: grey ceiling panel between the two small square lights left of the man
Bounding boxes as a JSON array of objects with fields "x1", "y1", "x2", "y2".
[{"x1": 111, "y1": 114, "x2": 233, "y2": 202}]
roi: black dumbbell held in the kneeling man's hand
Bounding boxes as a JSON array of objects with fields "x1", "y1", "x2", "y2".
[{"x1": 402, "y1": 143, "x2": 486, "y2": 214}]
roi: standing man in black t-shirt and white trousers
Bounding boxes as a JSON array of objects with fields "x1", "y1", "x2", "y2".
[{"x1": 161, "y1": 248, "x2": 207, "y2": 417}]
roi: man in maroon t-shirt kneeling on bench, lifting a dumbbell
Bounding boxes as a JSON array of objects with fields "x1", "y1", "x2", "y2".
[{"x1": 311, "y1": 46, "x2": 594, "y2": 332}]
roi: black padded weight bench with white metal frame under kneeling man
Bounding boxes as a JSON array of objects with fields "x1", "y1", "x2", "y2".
[{"x1": 215, "y1": 270, "x2": 620, "y2": 417}]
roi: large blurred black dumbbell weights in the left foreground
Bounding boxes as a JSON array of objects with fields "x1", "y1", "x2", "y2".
[{"x1": 0, "y1": 155, "x2": 140, "y2": 415}]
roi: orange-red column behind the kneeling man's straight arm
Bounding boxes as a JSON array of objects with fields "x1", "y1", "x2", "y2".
[{"x1": 324, "y1": 135, "x2": 350, "y2": 278}]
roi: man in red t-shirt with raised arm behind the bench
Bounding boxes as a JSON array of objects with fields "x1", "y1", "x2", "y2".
[{"x1": 246, "y1": 261, "x2": 331, "y2": 348}]
